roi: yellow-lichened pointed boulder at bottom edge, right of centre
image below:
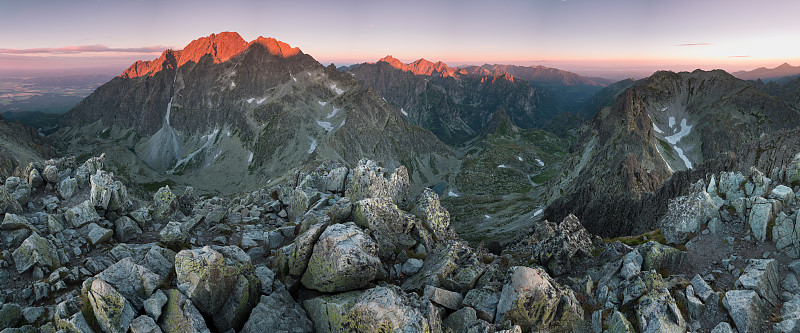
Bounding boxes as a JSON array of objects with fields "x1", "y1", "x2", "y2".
[{"x1": 495, "y1": 266, "x2": 583, "y2": 332}]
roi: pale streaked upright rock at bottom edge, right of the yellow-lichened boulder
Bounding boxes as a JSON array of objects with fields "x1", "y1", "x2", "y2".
[{"x1": 636, "y1": 290, "x2": 686, "y2": 333}]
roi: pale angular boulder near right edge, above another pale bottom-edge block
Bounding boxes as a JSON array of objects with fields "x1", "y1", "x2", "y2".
[{"x1": 736, "y1": 259, "x2": 780, "y2": 306}]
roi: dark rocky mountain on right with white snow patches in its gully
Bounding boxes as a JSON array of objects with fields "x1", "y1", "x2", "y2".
[{"x1": 545, "y1": 71, "x2": 800, "y2": 236}]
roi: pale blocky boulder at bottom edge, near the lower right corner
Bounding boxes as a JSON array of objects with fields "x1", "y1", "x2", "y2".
[{"x1": 722, "y1": 290, "x2": 769, "y2": 333}]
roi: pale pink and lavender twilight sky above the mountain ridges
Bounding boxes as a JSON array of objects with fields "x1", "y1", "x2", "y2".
[{"x1": 0, "y1": 0, "x2": 800, "y2": 76}]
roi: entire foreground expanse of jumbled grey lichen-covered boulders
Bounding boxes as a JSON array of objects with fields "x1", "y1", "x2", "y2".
[{"x1": 0, "y1": 151, "x2": 800, "y2": 333}]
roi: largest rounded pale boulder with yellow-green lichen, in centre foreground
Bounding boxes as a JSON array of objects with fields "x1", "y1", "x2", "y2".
[{"x1": 301, "y1": 222, "x2": 381, "y2": 292}]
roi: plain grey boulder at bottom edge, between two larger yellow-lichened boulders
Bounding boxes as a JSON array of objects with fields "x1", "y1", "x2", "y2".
[{"x1": 241, "y1": 291, "x2": 314, "y2": 333}]
